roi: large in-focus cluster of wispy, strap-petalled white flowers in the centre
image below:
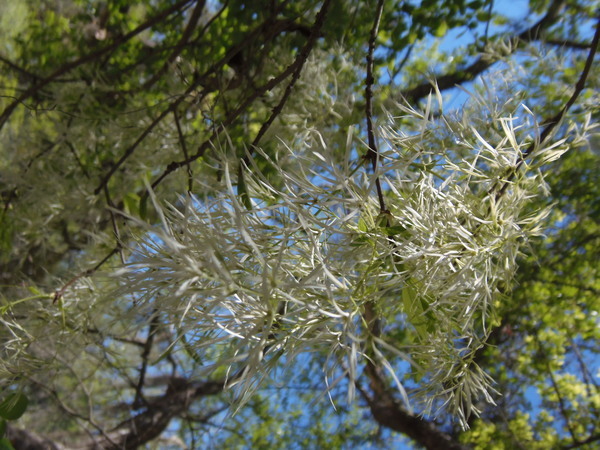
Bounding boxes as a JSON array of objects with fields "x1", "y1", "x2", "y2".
[{"x1": 117, "y1": 86, "x2": 563, "y2": 423}]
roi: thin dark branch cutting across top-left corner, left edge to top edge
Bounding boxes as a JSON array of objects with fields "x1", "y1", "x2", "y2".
[{"x1": 0, "y1": 0, "x2": 191, "y2": 129}]
